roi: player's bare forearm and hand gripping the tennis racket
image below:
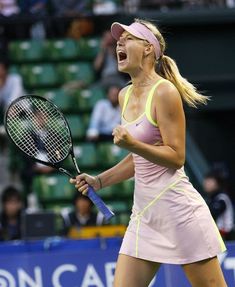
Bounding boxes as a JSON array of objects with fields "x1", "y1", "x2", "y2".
[{"x1": 70, "y1": 154, "x2": 135, "y2": 194}]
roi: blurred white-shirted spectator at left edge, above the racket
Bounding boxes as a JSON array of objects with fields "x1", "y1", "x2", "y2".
[{"x1": 0, "y1": 59, "x2": 24, "y2": 120}]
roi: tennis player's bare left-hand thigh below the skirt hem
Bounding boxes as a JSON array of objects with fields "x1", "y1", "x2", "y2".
[{"x1": 113, "y1": 254, "x2": 160, "y2": 287}]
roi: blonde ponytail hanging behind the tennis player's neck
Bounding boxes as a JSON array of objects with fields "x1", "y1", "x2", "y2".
[{"x1": 156, "y1": 55, "x2": 209, "y2": 108}]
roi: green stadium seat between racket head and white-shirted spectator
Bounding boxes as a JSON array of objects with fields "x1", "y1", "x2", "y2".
[{"x1": 66, "y1": 114, "x2": 86, "y2": 140}]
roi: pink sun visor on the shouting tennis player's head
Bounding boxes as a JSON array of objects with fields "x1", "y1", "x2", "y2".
[{"x1": 111, "y1": 22, "x2": 161, "y2": 59}]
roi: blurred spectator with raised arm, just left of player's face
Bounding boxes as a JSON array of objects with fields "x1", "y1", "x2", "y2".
[{"x1": 94, "y1": 31, "x2": 125, "y2": 87}]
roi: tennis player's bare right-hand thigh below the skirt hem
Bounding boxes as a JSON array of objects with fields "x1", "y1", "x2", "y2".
[{"x1": 182, "y1": 257, "x2": 227, "y2": 287}]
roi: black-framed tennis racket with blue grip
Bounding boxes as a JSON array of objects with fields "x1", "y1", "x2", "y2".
[{"x1": 4, "y1": 95, "x2": 114, "y2": 220}]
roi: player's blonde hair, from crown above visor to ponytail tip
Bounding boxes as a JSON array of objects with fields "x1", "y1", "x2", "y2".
[{"x1": 135, "y1": 19, "x2": 209, "y2": 108}]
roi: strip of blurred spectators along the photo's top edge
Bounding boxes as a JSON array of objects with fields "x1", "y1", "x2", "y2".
[{"x1": 0, "y1": 0, "x2": 235, "y2": 17}]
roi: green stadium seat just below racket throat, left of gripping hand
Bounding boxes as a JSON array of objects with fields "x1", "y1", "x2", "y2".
[{"x1": 33, "y1": 174, "x2": 75, "y2": 201}]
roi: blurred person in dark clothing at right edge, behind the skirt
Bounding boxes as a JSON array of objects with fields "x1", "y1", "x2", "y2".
[{"x1": 203, "y1": 173, "x2": 234, "y2": 239}]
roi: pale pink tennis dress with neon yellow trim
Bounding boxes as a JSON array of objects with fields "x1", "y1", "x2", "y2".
[{"x1": 120, "y1": 80, "x2": 226, "y2": 264}]
